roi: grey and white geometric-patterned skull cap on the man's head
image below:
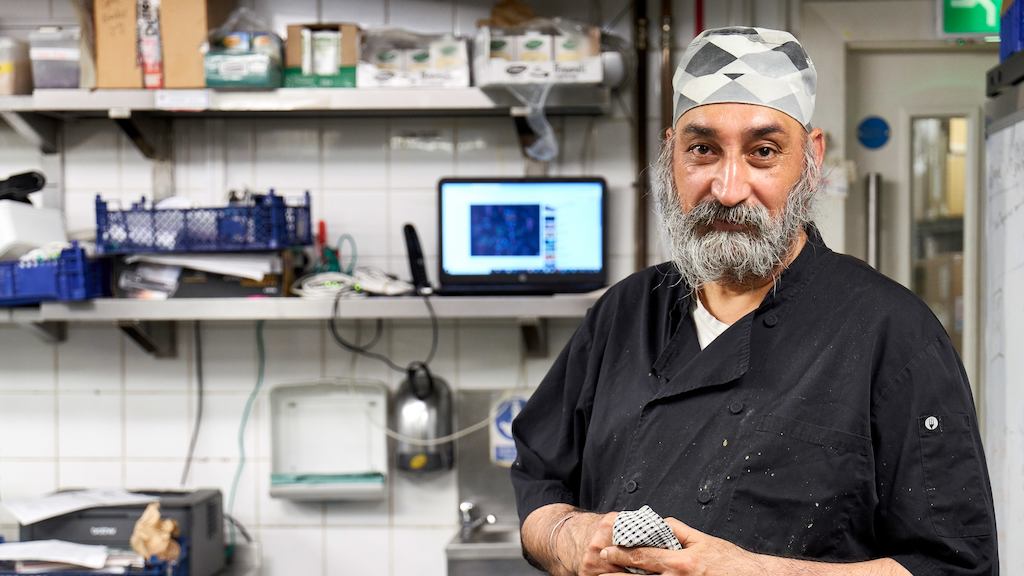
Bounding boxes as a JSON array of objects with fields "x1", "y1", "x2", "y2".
[{"x1": 672, "y1": 27, "x2": 817, "y2": 129}]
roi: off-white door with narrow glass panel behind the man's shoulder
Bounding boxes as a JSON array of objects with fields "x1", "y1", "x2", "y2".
[{"x1": 845, "y1": 47, "x2": 998, "y2": 391}]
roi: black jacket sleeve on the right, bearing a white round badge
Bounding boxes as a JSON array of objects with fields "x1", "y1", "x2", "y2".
[{"x1": 871, "y1": 334, "x2": 998, "y2": 576}]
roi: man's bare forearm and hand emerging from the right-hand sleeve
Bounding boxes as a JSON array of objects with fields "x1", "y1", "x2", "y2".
[{"x1": 600, "y1": 518, "x2": 911, "y2": 576}]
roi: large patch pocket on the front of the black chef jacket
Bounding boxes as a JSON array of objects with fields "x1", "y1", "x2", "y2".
[{"x1": 723, "y1": 415, "x2": 877, "y2": 560}]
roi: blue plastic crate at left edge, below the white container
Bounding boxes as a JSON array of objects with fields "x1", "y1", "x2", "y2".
[{"x1": 0, "y1": 243, "x2": 110, "y2": 306}]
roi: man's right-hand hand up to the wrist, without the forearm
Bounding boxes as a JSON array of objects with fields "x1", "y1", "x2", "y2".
[{"x1": 601, "y1": 518, "x2": 768, "y2": 576}]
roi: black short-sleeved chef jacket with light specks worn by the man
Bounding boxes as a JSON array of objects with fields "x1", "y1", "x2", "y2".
[{"x1": 511, "y1": 227, "x2": 998, "y2": 576}]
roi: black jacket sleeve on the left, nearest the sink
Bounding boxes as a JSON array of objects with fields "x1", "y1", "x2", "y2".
[{"x1": 511, "y1": 311, "x2": 593, "y2": 523}]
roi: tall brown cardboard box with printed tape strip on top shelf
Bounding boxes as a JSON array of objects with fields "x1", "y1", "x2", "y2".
[{"x1": 93, "y1": 0, "x2": 237, "y2": 88}]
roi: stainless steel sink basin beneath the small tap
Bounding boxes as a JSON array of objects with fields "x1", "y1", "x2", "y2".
[{"x1": 444, "y1": 526, "x2": 539, "y2": 576}]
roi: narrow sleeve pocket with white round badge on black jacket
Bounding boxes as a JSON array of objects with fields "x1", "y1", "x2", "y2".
[{"x1": 918, "y1": 414, "x2": 992, "y2": 538}]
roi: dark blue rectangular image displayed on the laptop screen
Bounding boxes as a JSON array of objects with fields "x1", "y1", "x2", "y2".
[{"x1": 469, "y1": 204, "x2": 541, "y2": 256}]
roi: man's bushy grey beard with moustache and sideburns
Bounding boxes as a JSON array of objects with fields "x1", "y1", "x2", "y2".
[{"x1": 652, "y1": 134, "x2": 821, "y2": 289}]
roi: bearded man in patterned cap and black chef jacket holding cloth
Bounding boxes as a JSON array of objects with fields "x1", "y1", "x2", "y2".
[{"x1": 511, "y1": 28, "x2": 998, "y2": 576}]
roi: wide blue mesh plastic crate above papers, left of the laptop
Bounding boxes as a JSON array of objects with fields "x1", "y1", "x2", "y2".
[{"x1": 96, "y1": 191, "x2": 312, "y2": 254}]
